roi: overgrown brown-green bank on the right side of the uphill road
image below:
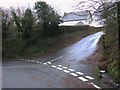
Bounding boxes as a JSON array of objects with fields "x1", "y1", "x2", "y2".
[{"x1": 99, "y1": 25, "x2": 120, "y2": 83}]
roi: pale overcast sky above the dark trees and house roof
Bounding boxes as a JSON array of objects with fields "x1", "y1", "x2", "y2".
[{"x1": 0, "y1": 0, "x2": 83, "y2": 14}]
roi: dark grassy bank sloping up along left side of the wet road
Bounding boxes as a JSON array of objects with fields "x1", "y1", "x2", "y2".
[{"x1": 3, "y1": 28, "x2": 99, "y2": 58}]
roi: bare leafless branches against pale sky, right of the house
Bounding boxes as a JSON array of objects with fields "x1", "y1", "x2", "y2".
[{"x1": 76, "y1": 0, "x2": 117, "y2": 24}]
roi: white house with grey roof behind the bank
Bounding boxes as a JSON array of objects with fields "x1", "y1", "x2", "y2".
[{"x1": 59, "y1": 10, "x2": 92, "y2": 26}]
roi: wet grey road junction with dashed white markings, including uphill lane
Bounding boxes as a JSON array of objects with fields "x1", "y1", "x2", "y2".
[{"x1": 2, "y1": 32, "x2": 104, "y2": 89}]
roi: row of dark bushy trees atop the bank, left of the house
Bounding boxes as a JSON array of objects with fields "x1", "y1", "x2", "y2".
[{"x1": 2, "y1": 1, "x2": 60, "y2": 39}]
